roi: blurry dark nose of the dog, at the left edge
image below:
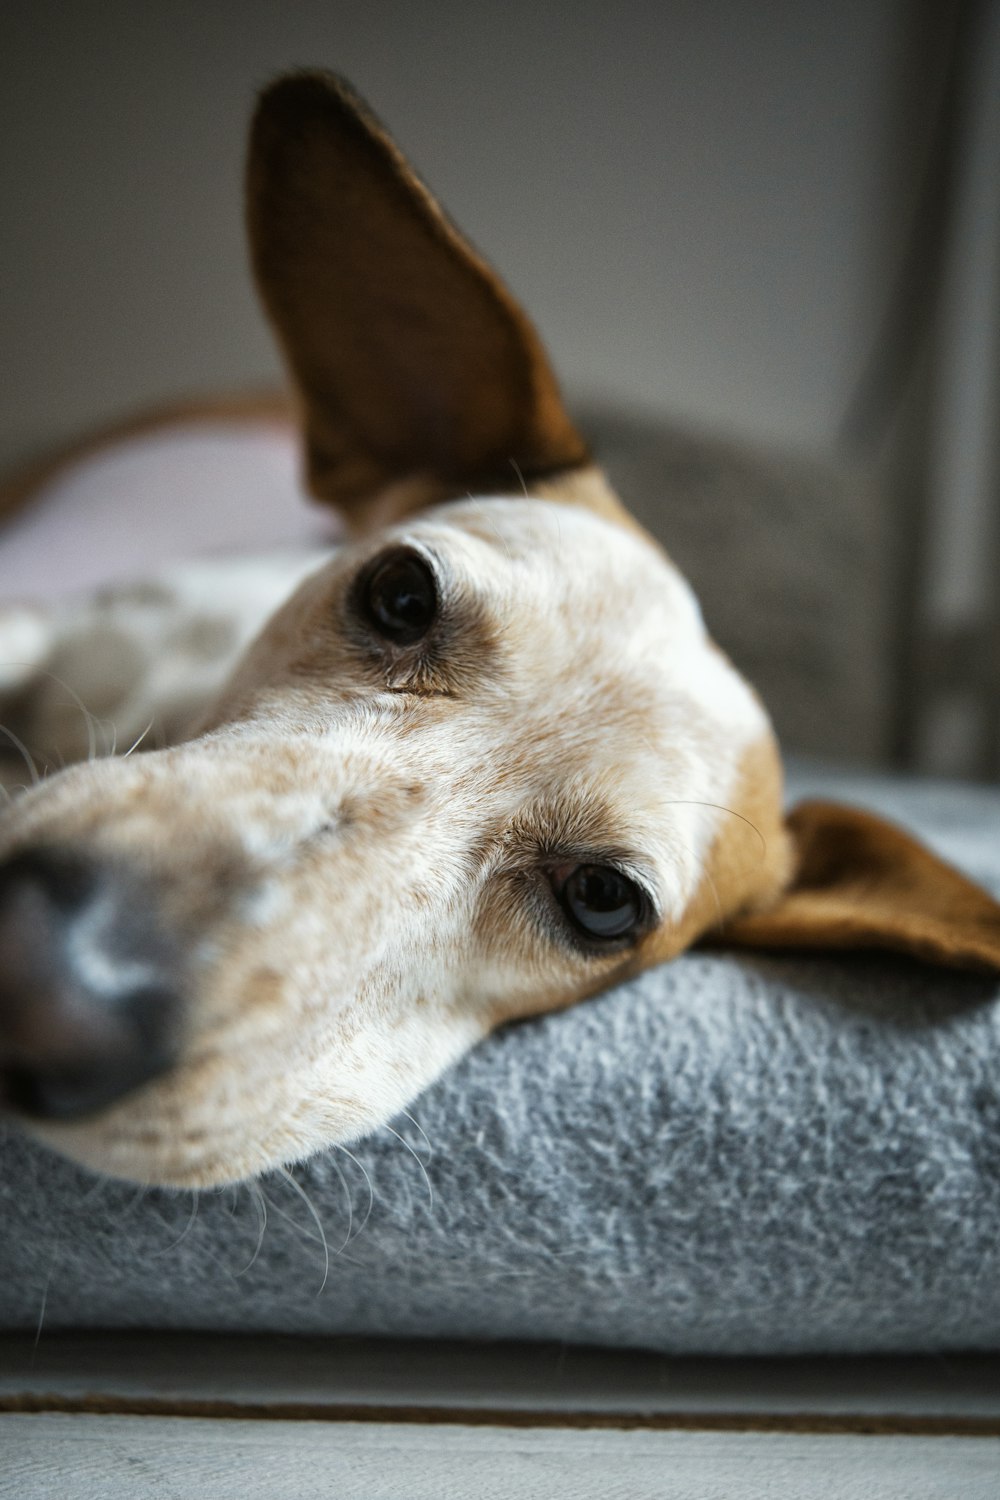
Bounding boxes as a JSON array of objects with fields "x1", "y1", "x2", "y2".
[{"x1": 0, "y1": 849, "x2": 181, "y2": 1119}]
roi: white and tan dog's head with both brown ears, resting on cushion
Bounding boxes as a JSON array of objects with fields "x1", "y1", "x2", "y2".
[{"x1": 0, "y1": 72, "x2": 1000, "y2": 1187}]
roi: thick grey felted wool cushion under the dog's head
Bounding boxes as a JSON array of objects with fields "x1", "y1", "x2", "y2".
[{"x1": 0, "y1": 771, "x2": 1000, "y2": 1355}]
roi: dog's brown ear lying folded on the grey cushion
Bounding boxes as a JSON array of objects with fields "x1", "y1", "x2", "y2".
[{"x1": 717, "y1": 803, "x2": 1000, "y2": 971}]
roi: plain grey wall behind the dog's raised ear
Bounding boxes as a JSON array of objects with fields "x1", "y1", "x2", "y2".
[{"x1": 0, "y1": 0, "x2": 924, "y2": 462}]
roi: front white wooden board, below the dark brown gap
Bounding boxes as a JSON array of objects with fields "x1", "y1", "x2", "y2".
[{"x1": 0, "y1": 1416, "x2": 1000, "y2": 1500}]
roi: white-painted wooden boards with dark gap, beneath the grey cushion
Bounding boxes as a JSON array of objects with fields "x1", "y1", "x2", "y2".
[{"x1": 0, "y1": 1334, "x2": 1000, "y2": 1500}]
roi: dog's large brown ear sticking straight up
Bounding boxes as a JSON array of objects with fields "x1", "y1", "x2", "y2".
[{"x1": 247, "y1": 74, "x2": 588, "y2": 524}]
